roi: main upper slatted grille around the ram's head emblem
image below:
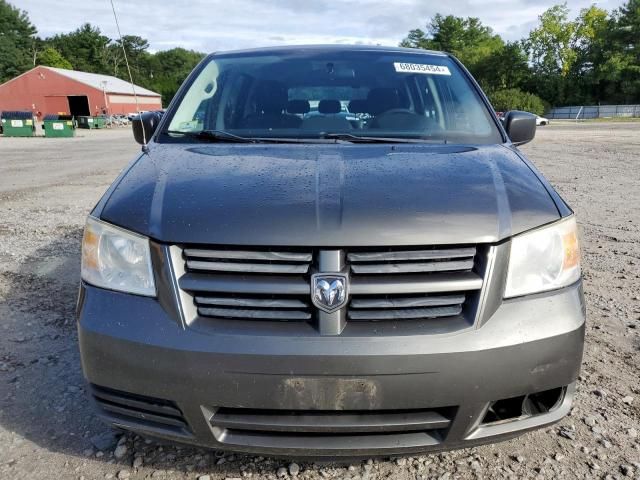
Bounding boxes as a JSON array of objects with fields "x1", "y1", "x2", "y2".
[{"x1": 178, "y1": 245, "x2": 488, "y2": 331}]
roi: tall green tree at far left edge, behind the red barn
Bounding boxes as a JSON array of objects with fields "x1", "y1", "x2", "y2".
[{"x1": 0, "y1": 0, "x2": 37, "y2": 83}]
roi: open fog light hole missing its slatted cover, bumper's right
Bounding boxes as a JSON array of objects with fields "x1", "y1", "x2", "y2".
[{"x1": 482, "y1": 387, "x2": 566, "y2": 424}]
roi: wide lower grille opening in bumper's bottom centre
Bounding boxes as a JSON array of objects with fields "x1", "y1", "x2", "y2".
[{"x1": 209, "y1": 407, "x2": 456, "y2": 449}]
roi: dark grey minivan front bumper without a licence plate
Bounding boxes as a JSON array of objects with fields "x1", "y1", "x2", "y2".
[{"x1": 78, "y1": 282, "x2": 585, "y2": 458}]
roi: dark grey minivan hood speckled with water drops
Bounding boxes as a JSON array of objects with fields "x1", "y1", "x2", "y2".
[{"x1": 100, "y1": 144, "x2": 559, "y2": 247}]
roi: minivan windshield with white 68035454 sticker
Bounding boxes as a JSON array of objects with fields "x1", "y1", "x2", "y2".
[{"x1": 164, "y1": 49, "x2": 502, "y2": 144}]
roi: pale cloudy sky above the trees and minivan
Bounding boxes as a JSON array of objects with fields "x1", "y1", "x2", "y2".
[{"x1": 18, "y1": 0, "x2": 625, "y2": 52}]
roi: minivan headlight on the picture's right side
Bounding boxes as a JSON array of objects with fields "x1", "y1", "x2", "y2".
[{"x1": 504, "y1": 216, "x2": 580, "y2": 297}]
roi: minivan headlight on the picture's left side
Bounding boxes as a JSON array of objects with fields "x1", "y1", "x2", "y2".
[{"x1": 81, "y1": 217, "x2": 156, "y2": 297}]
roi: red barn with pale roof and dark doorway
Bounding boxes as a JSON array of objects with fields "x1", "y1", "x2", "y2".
[{"x1": 0, "y1": 66, "x2": 162, "y2": 117}]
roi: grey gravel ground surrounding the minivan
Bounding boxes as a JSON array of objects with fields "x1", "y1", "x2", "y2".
[{"x1": 0, "y1": 123, "x2": 640, "y2": 480}]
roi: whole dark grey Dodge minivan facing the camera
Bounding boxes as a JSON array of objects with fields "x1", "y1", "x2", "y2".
[{"x1": 77, "y1": 45, "x2": 585, "y2": 458}]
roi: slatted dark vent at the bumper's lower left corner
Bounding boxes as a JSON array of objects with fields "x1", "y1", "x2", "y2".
[{"x1": 91, "y1": 385, "x2": 189, "y2": 435}]
